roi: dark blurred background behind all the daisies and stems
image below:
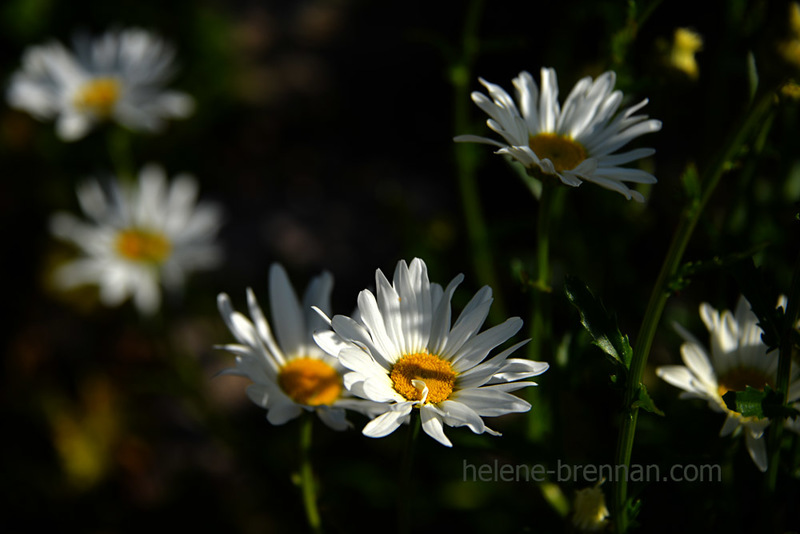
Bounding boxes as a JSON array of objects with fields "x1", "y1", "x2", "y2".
[{"x1": 0, "y1": 0, "x2": 800, "y2": 533}]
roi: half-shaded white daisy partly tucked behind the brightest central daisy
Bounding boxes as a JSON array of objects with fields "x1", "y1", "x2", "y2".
[{"x1": 217, "y1": 264, "x2": 382, "y2": 430}]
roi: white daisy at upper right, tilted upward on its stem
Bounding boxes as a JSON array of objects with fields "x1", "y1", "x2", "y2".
[{"x1": 455, "y1": 68, "x2": 661, "y2": 202}]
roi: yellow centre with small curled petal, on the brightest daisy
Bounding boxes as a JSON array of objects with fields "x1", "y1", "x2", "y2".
[{"x1": 389, "y1": 352, "x2": 456, "y2": 404}]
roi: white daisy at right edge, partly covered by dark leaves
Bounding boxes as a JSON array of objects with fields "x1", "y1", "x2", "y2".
[{"x1": 656, "y1": 297, "x2": 800, "y2": 471}]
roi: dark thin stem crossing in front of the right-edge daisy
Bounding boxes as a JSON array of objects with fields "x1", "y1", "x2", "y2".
[{"x1": 767, "y1": 247, "x2": 800, "y2": 493}]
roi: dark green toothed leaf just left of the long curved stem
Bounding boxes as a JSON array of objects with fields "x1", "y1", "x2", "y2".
[{"x1": 564, "y1": 276, "x2": 633, "y2": 371}]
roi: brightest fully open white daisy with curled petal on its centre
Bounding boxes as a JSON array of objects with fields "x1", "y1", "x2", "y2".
[{"x1": 317, "y1": 258, "x2": 548, "y2": 447}]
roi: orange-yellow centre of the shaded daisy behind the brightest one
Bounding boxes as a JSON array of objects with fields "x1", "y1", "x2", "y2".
[{"x1": 278, "y1": 358, "x2": 342, "y2": 406}]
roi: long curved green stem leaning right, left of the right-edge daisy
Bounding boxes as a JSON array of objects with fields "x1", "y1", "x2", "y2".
[{"x1": 613, "y1": 90, "x2": 775, "y2": 534}]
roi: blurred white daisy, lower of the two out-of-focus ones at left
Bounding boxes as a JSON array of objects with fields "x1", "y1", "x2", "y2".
[{"x1": 50, "y1": 164, "x2": 221, "y2": 314}]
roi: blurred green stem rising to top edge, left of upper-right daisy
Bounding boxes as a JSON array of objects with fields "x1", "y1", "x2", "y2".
[{"x1": 450, "y1": 0, "x2": 506, "y2": 322}]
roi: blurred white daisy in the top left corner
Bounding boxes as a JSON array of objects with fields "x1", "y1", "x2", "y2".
[{"x1": 7, "y1": 28, "x2": 194, "y2": 141}]
